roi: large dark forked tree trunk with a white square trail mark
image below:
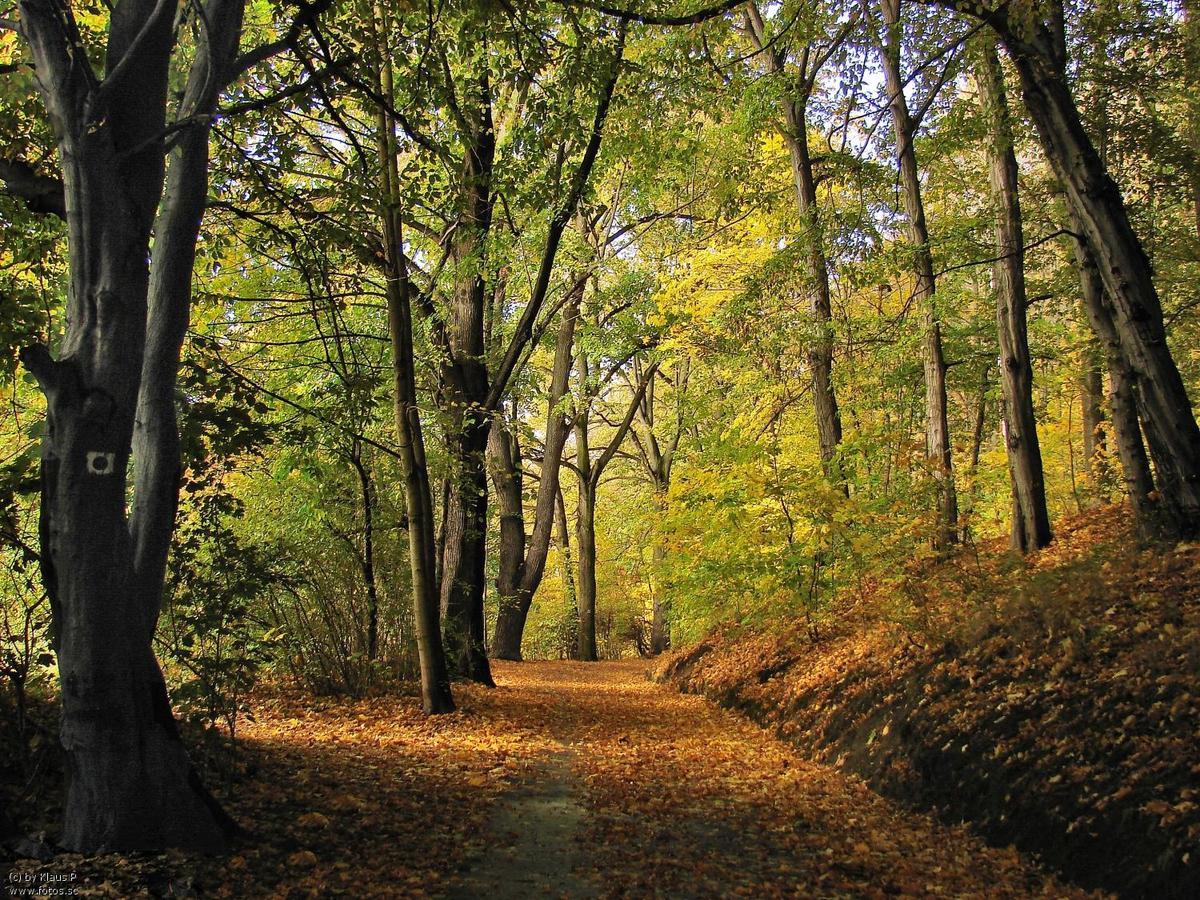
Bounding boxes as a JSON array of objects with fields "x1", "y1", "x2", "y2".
[{"x1": 20, "y1": 0, "x2": 242, "y2": 853}]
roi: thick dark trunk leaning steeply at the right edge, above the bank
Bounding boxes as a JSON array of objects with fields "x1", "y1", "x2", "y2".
[{"x1": 990, "y1": 5, "x2": 1200, "y2": 536}]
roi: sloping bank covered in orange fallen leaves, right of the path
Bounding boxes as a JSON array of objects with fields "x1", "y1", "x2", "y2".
[{"x1": 660, "y1": 508, "x2": 1200, "y2": 898}]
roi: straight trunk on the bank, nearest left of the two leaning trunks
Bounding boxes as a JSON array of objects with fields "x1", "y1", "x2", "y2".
[{"x1": 977, "y1": 36, "x2": 1050, "y2": 553}]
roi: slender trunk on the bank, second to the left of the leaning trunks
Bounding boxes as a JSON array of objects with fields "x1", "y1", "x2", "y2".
[{"x1": 880, "y1": 0, "x2": 959, "y2": 550}]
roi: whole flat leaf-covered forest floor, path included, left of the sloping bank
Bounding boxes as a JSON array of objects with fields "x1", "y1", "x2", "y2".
[{"x1": 6, "y1": 661, "x2": 1086, "y2": 898}]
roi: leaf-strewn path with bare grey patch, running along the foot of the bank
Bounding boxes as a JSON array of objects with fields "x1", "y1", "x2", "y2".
[{"x1": 449, "y1": 660, "x2": 1089, "y2": 898}]
